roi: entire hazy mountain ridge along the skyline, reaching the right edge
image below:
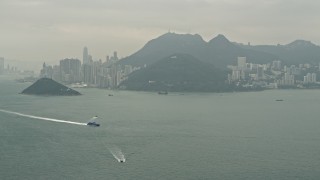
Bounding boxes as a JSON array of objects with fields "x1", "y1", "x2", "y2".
[{"x1": 119, "y1": 32, "x2": 320, "y2": 68}]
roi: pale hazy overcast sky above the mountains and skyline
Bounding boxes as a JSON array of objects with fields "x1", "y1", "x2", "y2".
[{"x1": 0, "y1": 0, "x2": 320, "y2": 69}]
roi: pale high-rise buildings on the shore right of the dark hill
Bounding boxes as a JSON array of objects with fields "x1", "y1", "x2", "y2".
[{"x1": 228, "y1": 57, "x2": 320, "y2": 88}]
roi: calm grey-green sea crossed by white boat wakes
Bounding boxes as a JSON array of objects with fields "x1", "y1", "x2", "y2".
[{"x1": 0, "y1": 76, "x2": 320, "y2": 180}]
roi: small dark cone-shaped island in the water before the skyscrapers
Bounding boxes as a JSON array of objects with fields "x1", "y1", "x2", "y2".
[{"x1": 21, "y1": 78, "x2": 81, "y2": 96}]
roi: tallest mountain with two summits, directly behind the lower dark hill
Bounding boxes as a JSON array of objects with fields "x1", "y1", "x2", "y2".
[{"x1": 120, "y1": 33, "x2": 277, "y2": 68}]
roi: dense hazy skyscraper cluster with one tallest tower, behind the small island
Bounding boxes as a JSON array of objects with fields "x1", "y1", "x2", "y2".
[{"x1": 40, "y1": 47, "x2": 139, "y2": 89}]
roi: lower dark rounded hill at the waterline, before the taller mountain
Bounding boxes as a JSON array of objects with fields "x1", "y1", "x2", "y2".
[{"x1": 120, "y1": 54, "x2": 229, "y2": 92}]
